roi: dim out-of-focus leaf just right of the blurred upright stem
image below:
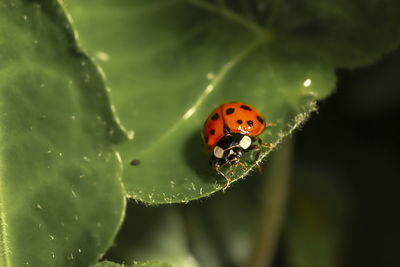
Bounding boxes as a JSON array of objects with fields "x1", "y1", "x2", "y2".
[{"x1": 284, "y1": 168, "x2": 349, "y2": 267}]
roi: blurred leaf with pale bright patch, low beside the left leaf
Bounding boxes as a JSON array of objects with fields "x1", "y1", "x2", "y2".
[{"x1": 105, "y1": 202, "x2": 200, "y2": 267}]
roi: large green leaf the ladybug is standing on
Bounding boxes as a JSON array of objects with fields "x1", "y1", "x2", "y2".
[{"x1": 68, "y1": 0, "x2": 399, "y2": 203}]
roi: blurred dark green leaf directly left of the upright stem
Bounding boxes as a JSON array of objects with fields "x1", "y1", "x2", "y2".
[{"x1": 185, "y1": 183, "x2": 265, "y2": 266}]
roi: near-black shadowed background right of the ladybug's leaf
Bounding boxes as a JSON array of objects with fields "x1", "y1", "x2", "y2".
[{"x1": 295, "y1": 50, "x2": 400, "y2": 267}]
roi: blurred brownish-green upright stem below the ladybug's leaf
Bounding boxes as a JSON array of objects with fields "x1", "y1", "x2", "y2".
[{"x1": 247, "y1": 138, "x2": 292, "y2": 267}]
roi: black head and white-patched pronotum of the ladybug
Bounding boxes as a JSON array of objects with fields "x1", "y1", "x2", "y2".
[{"x1": 213, "y1": 134, "x2": 252, "y2": 166}]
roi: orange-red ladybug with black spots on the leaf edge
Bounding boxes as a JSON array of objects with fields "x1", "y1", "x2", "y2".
[{"x1": 202, "y1": 102, "x2": 274, "y2": 191}]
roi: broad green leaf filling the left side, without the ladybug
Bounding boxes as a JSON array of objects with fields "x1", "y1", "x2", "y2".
[{"x1": 0, "y1": 0, "x2": 125, "y2": 267}]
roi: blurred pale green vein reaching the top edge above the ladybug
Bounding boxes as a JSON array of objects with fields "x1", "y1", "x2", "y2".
[{"x1": 186, "y1": 0, "x2": 273, "y2": 41}]
